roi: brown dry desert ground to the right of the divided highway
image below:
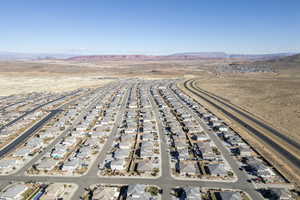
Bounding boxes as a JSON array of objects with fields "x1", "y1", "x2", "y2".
[{"x1": 199, "y1": 70, "x2": 300, "y2": 141}]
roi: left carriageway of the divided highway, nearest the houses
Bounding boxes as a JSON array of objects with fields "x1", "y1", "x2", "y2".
[{"x1": 185, "y1": 79, "x2": 300, "y2": 169}]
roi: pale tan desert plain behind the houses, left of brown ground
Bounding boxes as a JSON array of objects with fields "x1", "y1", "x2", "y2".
[{"x1": 0, "y1": 60, "x2": 222, "y2": 96}]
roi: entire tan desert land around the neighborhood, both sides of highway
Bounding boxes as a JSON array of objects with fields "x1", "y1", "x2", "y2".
[{"x1": 0, "y1": 60, "x2": 300, "y2": 144}]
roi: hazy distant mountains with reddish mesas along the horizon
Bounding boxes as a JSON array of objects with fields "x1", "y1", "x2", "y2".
[{"x1": 0, "y1": 52, "x2": 295, "y2": 62}]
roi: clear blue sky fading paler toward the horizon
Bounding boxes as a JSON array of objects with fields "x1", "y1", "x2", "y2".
[{"x1": 0, "y1": 0, "x2": 300, "y2": 54}]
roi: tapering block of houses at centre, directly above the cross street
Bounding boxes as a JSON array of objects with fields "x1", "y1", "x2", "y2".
[{"x1": 100, "y1": 84, "x2": 161, "y2": 177}]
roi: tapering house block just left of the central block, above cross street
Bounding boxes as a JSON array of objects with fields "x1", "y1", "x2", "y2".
[{"x1": 28, "y1": 83, "x2": 124, "y2": 176}]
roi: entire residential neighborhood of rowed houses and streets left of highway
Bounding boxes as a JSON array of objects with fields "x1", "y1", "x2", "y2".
[{"x1": 0, "y1": 78, "x2": 297, "y2": 200}]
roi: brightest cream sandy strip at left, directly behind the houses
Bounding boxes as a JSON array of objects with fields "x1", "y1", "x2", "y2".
[{"x1": 0, "y1": 72, "x2": 113, "y2": 96}]
